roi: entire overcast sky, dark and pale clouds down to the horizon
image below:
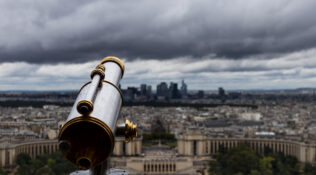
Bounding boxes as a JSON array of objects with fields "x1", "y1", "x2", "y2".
[{"x1": 0, "y1": 0, "x2": 316, "y2": 90}]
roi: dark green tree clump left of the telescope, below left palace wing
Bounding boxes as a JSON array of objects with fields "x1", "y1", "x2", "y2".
[{"x1": 15, "y1": 152, "x2": 77, "y2": 175}]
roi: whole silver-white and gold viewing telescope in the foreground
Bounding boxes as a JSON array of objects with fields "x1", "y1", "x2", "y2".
[{"x1": 59, "y1": 56, "x2": 137, "y2": 170}]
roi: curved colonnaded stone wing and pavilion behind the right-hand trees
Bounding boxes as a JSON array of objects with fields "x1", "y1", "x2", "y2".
[{"x1": 177, "y1": 129, "x2": 316, "y2": 163}]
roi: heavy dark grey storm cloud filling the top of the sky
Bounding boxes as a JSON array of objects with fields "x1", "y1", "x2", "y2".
[{"x1": 0, "y1": 0, "x2": 316, "y2": 63}]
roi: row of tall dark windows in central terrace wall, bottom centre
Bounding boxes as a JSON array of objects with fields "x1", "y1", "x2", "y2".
[{"x1": 144, "y1": 163, "x2": 176, "y2": 172}]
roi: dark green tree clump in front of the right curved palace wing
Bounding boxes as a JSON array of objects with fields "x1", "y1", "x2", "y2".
[{"x1": 209, "y1": 145, "x2": 316, "y2": 175}]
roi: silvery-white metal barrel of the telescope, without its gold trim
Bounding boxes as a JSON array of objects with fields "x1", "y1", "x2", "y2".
[{"x1": 67, "y1": 62, "x2": 122, "y2": 133}]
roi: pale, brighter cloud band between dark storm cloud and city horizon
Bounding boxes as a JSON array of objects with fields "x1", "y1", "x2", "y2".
[{"x1": 0, "y1": 49, "x2": 316, "y2": 90}]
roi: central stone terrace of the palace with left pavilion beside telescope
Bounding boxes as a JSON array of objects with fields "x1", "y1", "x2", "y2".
[{"x1": 110, "y1": 138, "x2": 211, "y2": 175}]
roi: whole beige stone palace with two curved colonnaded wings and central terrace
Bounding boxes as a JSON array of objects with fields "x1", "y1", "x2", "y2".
[{"x1": 0, "y1": 130, "x2": 316, "y2": 175}]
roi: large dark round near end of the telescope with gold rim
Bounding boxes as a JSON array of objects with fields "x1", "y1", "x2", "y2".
[{"x1": 58, "y1": 116, "x2": 115, "y2": 169}]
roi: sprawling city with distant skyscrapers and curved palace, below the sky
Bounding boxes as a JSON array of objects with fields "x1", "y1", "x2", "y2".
[{"x1": 0, "y1": 80, "x2": 316, "y2": 174}]
